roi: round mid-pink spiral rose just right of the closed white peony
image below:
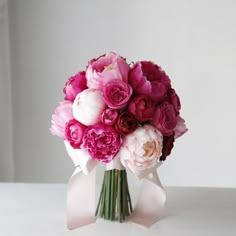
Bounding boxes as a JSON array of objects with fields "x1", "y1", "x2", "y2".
[{"x1": 102, "y1": 79, "x2": 132, "y2": 109}]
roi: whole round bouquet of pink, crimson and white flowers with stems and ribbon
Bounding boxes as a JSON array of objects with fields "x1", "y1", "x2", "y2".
[{"x1": 50, "y1": 52, "x2": 187, "y2": 228}]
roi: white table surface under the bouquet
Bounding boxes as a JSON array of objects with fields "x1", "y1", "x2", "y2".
[{"x1": 0, "y1": 183, "x2": 236, "y2": 236}]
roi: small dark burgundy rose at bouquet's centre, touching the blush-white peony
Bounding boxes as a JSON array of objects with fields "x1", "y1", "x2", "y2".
[{"x1": 115, "y1": 112, "x2": 138, "y2": 135}]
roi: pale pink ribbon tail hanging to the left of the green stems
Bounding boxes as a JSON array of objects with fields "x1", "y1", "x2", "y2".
[{"x1": 67, "y1": 167, "x2": 96, "y2": 230}]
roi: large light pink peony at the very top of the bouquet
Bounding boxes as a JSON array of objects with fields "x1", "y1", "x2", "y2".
[{"x1": 86, "y1": 52, "x2": 130, "y2": 89}]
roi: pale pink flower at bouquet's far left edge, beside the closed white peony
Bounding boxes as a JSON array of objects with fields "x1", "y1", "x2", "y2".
[{"x1": 49, "y1": 101, "x2": 74, "y2": 138}]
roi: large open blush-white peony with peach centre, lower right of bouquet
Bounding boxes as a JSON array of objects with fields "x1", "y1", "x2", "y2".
[{"x1": 119, "y1": 125, "x2": 163, "y2": 173}]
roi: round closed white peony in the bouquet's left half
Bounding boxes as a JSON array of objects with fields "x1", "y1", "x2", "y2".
[{"x1": 73, "y1": 89, "x2": 106, "y2": 126}]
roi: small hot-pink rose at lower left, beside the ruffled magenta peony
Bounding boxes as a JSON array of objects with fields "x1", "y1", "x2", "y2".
[{"x1": 65, "y1": 119, "x2": 86, "y2": 148}]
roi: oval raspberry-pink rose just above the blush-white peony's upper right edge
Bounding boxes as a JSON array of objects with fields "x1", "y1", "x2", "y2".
[{"x1": 153, "y1": 102, "x2": 177, "y2": 136}]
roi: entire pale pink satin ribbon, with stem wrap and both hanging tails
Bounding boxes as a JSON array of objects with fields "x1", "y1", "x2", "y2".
[{"x1": 65, "y1": 141, "x2": 166, "y2": 229}]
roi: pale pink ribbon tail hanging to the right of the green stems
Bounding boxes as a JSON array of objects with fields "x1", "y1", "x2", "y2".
[{"x1": 129, "y1": 170, "x2": 166, "y2": 227}]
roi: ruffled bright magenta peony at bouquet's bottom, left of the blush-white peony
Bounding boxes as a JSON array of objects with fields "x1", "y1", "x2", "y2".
[{"x1": 82, "y1": 124, "x2": 121, "y2": 163}]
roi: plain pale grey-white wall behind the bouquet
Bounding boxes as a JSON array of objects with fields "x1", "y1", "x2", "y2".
[{"x1": 0, "y1": 0, "x2": 236, "y2": 187}]
